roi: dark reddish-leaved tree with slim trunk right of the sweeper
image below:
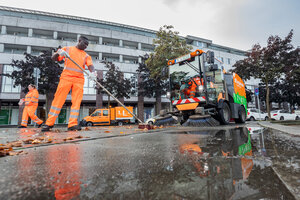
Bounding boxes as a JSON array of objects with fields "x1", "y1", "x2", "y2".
[{"x1": 233, "y1": 30, "x2": 293, "y2": 117}]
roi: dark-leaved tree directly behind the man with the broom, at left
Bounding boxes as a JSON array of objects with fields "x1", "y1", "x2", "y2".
[{"x1": 6, "y1": 51, "x2": 62, "y2": 117}]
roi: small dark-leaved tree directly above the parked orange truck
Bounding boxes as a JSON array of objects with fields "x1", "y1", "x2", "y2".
[{"x1": 98, "y1": 62, "x2": 134, "y2": 107}]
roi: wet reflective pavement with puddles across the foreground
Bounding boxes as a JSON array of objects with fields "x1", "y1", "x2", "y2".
[{"x1": 0, "y1": 124, "x2": 300, "y2": 199}]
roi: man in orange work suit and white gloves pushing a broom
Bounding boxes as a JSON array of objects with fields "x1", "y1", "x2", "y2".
[{"x1": 42, "y1": 36, "x2": 97, "y2": 131}]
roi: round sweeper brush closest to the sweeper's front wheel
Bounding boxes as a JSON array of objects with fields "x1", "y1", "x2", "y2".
[{"x1": 183, "y1": 115, "x2": 220, "y2": 127}]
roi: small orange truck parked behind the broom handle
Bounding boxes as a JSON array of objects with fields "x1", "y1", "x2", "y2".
[{"x1": 80, "y1": 106, "x2": 133, "y2": 126}]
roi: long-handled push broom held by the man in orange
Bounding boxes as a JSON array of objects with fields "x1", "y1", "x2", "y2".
[{"x1": 65, "y1": 52, "x2": 153, "y2": 129}]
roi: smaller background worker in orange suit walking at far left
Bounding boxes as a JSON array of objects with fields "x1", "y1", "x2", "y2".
[{"x1": 19, "y1": 84, "x2": 43, "y2": 128}]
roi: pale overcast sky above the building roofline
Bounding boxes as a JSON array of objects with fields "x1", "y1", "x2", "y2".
[{"x1": 0, "y1": 0, "x2": 300, "y2": 50}]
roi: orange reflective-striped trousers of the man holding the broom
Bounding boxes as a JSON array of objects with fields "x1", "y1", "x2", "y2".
[{"x1": 46, "y1": 79, "x2": 84, "y2": 127}]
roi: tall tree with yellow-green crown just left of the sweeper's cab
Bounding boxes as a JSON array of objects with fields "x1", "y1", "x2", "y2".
[{"x1": 145, "y1": 25, "x2": 192, "y2": 114}]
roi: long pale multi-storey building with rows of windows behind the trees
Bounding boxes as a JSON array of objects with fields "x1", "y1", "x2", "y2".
[{"x1": 0, "y1": 6, "x2": 255, "y2": 124}]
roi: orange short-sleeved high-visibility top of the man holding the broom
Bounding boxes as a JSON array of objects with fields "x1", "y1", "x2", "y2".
[{"x1": 58, "y1": 46, "x2": 93, "y2": 81}]
